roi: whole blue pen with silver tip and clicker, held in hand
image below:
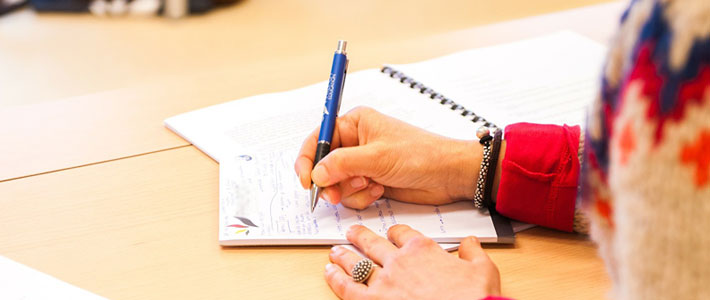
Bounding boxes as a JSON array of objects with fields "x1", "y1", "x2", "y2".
[{"x1": 311, "y1": 40, "x2": 348, "y2": 212}]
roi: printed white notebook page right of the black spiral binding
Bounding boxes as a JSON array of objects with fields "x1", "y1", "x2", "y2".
[{"x1": 392, "y1": 31, "x2": 606, "y2": 128}]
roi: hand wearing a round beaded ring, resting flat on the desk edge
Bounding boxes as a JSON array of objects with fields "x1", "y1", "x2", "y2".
[{"x1": 325, "y1": 225, "x2": 500, "y2": 300}]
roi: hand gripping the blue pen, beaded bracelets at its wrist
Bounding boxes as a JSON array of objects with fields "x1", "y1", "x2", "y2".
[{"x1": 295, "y1": 107, "x2": 483, "y2": 209}]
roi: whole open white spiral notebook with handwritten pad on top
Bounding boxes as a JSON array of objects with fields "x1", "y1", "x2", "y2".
[{"x1": 165, "y1": 32, "x2": 605, "y2": 245}]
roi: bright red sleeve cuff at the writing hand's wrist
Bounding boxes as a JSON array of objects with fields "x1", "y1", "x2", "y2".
[{"x1": 496, "y1": 123, "x2": 580, "y2": 231}]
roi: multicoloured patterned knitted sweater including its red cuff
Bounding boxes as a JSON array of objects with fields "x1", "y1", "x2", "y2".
[{"x1": 496, "y1": 0, "x2": 710, "y2": 299}]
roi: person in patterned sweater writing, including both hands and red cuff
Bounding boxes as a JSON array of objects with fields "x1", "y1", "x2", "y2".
[{"x1": 295, "y1": 0, "x2": 710, "y2": 299}]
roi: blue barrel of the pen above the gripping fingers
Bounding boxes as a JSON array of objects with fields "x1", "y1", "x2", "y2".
[{"x1": 318, "y1": 53, "x2": 348, "y2": 144}]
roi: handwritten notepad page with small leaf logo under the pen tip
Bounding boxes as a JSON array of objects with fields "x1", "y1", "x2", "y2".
[{"x1": 219, "y1": 151, "x2": 497, "y2": 245}]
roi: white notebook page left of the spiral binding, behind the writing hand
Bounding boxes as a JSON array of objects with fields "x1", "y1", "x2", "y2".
[{"x1": 165, "y1": 69, "x2": 475, "y2": 161}]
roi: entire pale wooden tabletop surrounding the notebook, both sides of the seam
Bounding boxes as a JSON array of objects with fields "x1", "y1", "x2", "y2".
[{"x1": 0, "y1": 0, "x2": 622, "y2": 299}]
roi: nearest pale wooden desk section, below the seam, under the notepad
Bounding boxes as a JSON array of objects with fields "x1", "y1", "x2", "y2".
[{"x1": 0, "y1": 146, "x2": 609, "y2": 299}]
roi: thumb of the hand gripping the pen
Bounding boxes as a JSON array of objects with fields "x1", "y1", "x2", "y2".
[{"x1": 311, "y1": 144, "x2": 379, "y2": 186}]
